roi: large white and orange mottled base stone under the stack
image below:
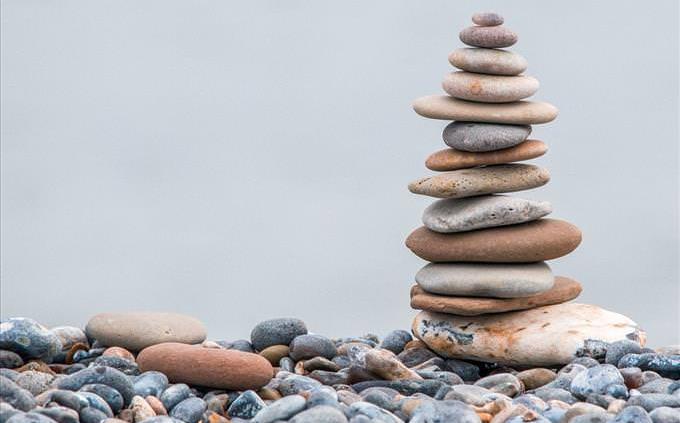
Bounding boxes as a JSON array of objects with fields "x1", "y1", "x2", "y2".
[{"x1": 412, "y1": 303, "x2": 646, "y2": 367}]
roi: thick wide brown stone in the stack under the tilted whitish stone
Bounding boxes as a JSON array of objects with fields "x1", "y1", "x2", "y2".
[{"x1": 406, "y1": 219, "x2": 581, "y2": 263}]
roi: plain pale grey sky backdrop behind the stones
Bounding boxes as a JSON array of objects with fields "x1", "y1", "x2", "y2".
[{"x1": 2, "y1": 0, "x2": 680, "y2": 345}]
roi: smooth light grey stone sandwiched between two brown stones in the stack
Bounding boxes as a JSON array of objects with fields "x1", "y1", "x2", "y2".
[{"x1": 416, "y1": 262, "x2": 555, "y2": 298}]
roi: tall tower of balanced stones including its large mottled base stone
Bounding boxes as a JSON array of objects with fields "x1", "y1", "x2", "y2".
[{"x1": 406, "y1": 13, "x2": 644, "y2": 365}]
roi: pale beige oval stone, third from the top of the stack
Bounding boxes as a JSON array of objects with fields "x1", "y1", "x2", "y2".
[{"x1": 449, "y1": 48, "x2": 528, "y2": 76}]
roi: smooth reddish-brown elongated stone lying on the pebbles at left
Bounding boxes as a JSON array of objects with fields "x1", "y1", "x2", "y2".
[{"x1": 137, "y1": 342, "x2": 274, "y2": 391}]
